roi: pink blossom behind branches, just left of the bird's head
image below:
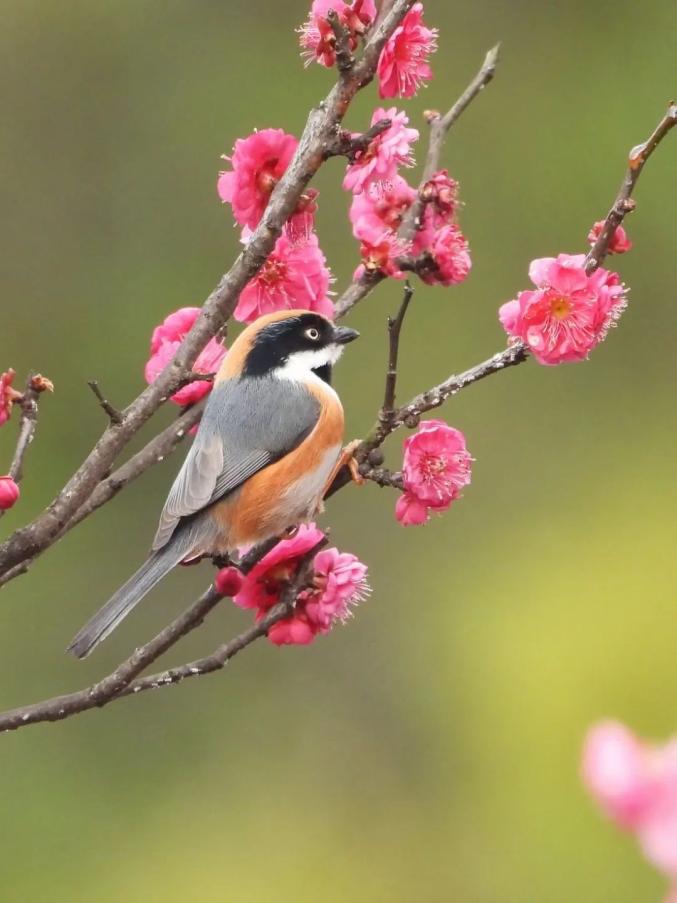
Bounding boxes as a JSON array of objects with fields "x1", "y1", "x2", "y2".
[{"x1": 144, "y1": 307, "x2": 226, "y2": 406}]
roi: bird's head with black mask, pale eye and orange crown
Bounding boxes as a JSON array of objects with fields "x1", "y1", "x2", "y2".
[{"x1": 242, "y1": 311, "x2": 359, "y2": 382}]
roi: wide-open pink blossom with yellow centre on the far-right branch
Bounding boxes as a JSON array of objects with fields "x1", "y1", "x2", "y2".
[{"x1": 499, "y1": 254, "x2": 626, "y2": 364}]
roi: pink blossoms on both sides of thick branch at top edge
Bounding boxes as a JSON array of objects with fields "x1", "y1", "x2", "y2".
[{"x1": 299, "y1": 0, "x2": 437, "y2": 97}]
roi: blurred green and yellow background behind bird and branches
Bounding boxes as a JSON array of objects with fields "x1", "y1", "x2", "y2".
[{"x1": 0, "y1": 0, "x2": 677, "y2": 903}]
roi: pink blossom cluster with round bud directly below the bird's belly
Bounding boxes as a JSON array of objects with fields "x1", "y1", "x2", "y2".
[{"x1": 215, "y1": 524, "x2": 369, "y2": 646}]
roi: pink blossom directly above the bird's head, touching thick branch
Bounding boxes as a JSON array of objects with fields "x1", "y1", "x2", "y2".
[{"x1": 235, "y1": 230, "x2": 334, "y2": 323}]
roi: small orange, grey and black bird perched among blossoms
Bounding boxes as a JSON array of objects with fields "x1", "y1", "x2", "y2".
[{"x1": 68, "y1": 310, "x2": 359, "y2": 658}]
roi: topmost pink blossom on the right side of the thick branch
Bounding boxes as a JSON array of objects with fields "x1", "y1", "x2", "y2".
[{"x1": 377, "y1": 3, "x2": 437, "y2": 97}]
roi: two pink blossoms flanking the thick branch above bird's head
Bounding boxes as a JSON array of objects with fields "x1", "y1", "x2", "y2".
[{"x1": 217, "y1": 129, "x2": 334, "y2": 323}]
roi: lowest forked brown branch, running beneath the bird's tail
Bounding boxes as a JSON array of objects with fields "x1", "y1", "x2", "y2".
[{"x1": 0, "y1": 539, "x2": 326, "y2": 733}]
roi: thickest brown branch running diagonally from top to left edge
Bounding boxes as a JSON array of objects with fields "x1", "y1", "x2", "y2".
[{"x1": 0, "y1": 0, "x2": 414, "y2": 575}]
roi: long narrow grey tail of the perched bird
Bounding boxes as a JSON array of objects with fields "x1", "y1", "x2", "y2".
[{"x1": 68, "y1": 524, "x2": 201, "y2": 658}]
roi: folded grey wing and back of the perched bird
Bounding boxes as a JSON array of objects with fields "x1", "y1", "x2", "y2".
[{"x1": 153, "y1": 376, "x2": 320, "y2": 550}]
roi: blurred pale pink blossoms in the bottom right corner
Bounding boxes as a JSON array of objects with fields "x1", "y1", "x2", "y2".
[{"x1": 583, "y1": 721, "x2": 677, "y2": 899}]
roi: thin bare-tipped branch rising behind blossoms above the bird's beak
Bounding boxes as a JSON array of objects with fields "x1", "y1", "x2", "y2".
[{"x1": 334, "y1": 44, "x2": 500, "y2": 320}]
